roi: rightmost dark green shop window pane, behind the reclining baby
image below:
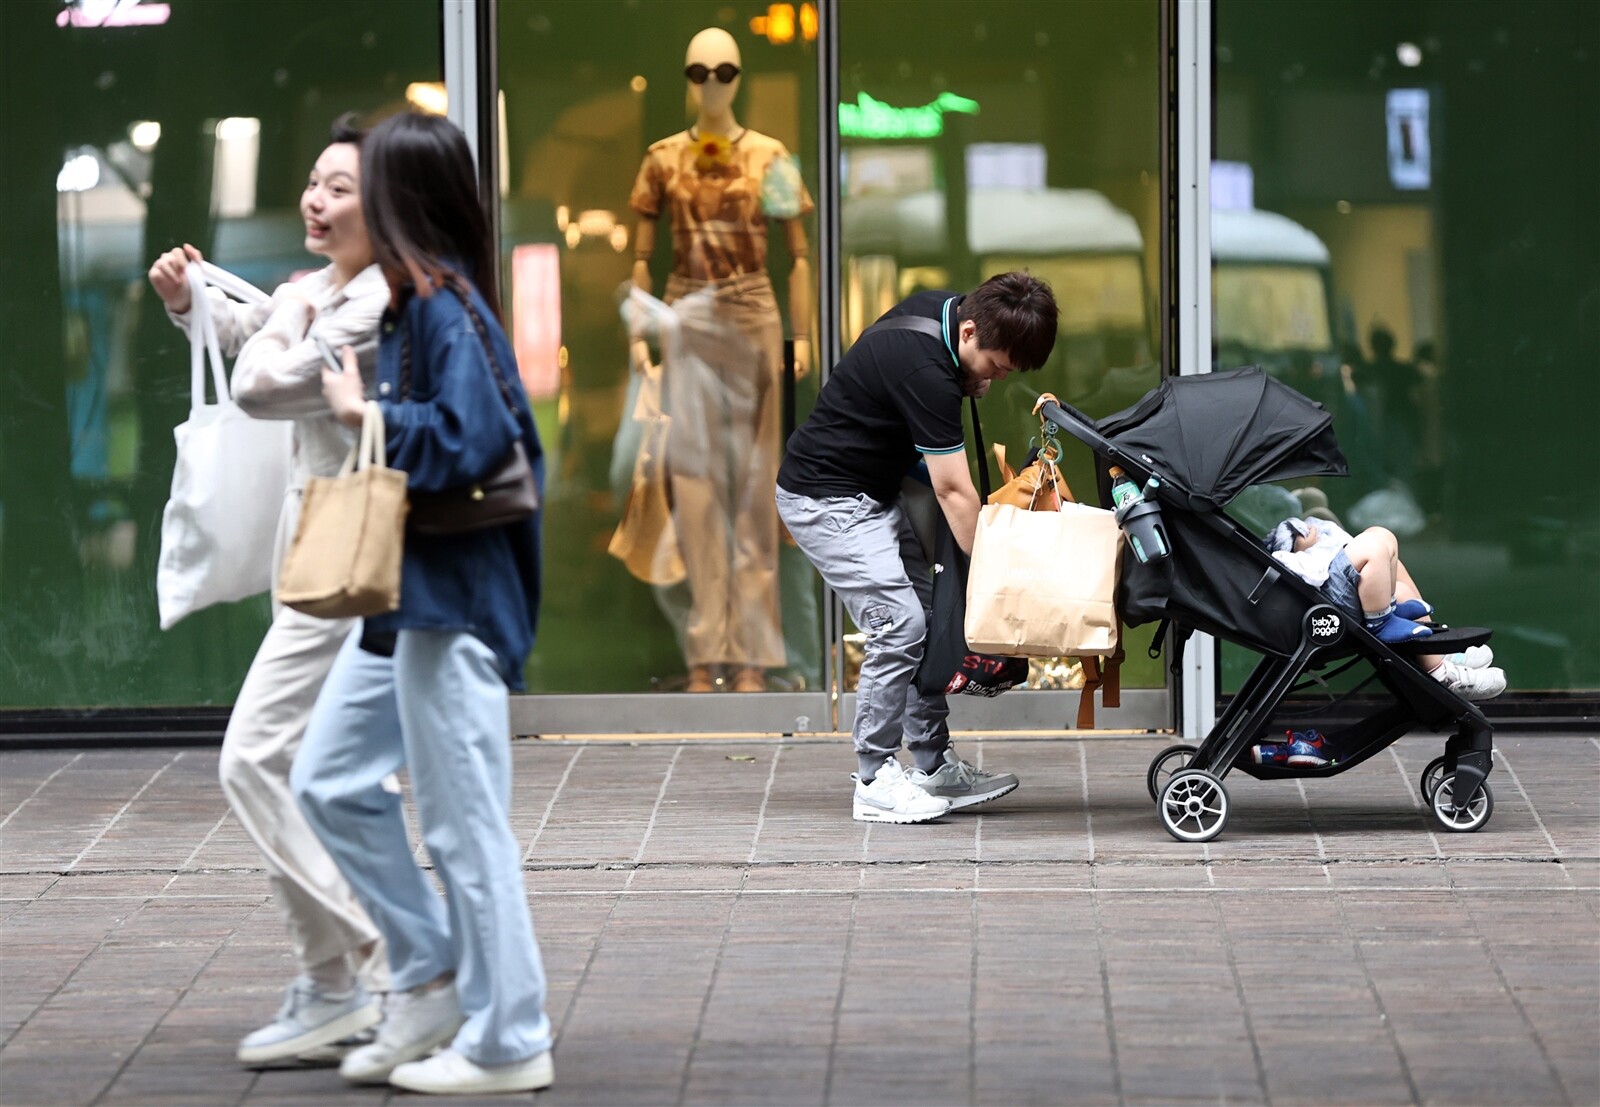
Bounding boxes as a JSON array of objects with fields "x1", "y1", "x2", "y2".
[{"x1": 1211, "y1": 0, "x2": 1600, "y2": 697}]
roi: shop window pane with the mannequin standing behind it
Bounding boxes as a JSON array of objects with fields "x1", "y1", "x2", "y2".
[{"x1": 498, "y1": 0, "x2": 822, "y2": 693}]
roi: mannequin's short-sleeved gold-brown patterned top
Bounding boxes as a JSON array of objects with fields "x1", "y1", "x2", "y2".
[{"x1": 629, "y1": 130, "x2": 814, "y2": 280}]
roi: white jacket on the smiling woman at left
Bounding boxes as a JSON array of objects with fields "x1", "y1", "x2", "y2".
[{"x1": 168, "y1": 266, "x2": 389, "y2": 486}]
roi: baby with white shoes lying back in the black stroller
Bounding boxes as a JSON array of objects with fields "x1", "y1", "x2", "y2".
[{"x1": 1266, "y1": 518, "x2": 1506, "y2": 699}]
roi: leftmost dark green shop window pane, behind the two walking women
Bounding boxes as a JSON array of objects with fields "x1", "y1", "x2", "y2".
[{"x1": 0, "y1": 0, "x2": 440, "y2": 709}]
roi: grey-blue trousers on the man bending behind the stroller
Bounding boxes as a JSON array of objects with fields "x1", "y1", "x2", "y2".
[{"x1": 778, "y1": 488, "x2": 950, "y2": 776}]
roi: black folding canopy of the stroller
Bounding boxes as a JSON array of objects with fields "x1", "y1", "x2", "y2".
[{"x1": 1096, "y1": 366, "x2": 1349, "y2": 510}]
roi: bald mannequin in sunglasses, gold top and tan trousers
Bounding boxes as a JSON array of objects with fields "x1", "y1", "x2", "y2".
[{"x1": 629, "y1": 27, "x2": 813, "y2": 691}]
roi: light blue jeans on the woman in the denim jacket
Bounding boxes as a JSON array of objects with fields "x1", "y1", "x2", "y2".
[{"x1": 290, "y1": 629, "x2": 550, "y2": 1065}]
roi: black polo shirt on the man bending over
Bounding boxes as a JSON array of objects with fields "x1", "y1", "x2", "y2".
[{"x1": 778, "y1": 291, "x2": 965, "y2": 504}]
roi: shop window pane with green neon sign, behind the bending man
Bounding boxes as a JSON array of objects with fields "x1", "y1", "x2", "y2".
[{"x1": 838, "y1": 0, "x2": 1165, "y2": 688}]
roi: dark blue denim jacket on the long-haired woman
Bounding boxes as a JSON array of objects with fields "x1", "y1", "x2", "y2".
[{"x1": 362, "y1": 271, "x2": 544, "y2": 691}]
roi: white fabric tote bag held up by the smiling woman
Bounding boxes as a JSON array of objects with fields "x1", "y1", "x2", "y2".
[{"x1": 155, "y1": 264, "x2": 294, "y2": 630}]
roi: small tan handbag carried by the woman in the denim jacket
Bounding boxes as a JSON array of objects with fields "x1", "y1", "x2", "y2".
[{"x1": 278, "y1": 402, "x2": 408, "y2": 619}]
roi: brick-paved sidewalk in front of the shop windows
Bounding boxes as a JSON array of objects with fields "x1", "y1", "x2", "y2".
[{"x1": 0, "y1": 736, "x2": 1600, "y2": 1107}]
